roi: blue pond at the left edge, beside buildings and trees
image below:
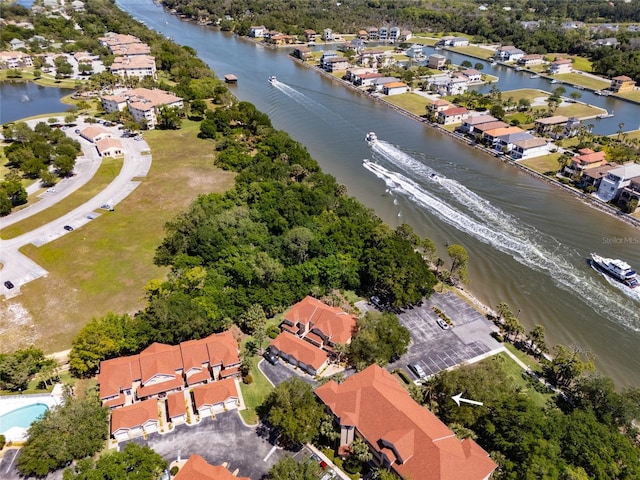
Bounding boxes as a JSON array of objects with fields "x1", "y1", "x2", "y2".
[{"x1": 0, "y1": 82, "x2": 73, "y2": 123}]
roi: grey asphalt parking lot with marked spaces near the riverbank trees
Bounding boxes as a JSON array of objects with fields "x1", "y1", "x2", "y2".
[{"x1": 387, "y1": 293, "x2": 501, "y2": 380}]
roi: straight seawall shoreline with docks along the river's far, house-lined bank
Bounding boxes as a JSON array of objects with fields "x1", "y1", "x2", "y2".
[{"x1": 288, "y1": 54, "x2": 640, "y2": 229}]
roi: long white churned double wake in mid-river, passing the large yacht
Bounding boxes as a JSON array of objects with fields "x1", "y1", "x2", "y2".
[{"x1": 363, "y1": 140, "x2": 640, "y2": 331}]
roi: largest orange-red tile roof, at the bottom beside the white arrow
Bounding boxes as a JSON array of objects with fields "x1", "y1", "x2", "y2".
[{"x1": 316, "y1": 364, "x2": 497, "y2": 480}]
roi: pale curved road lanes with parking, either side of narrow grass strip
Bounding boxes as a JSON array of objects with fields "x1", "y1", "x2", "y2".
[{"x1": 0, "y1": 120, "x2": 151, "y2": 298}]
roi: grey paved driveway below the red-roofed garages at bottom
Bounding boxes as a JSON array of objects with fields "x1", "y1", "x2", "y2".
[{"x1": 121, "y1": 411, "x2": 286, "y2": 480}]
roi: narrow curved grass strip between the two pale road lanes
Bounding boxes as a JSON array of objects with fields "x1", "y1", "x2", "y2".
[{"x1": 0, "y1": 158, "x2": 122, "y2": 240}]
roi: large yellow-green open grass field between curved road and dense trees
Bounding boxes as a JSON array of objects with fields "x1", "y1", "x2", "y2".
[{"x1": 0, "y1": 121, "x2": 234, "y2": 352}]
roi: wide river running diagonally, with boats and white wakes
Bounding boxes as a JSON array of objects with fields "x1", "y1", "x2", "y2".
[{"x1": 118, "y1": 0, "x2": 640, "y2": 385}]
